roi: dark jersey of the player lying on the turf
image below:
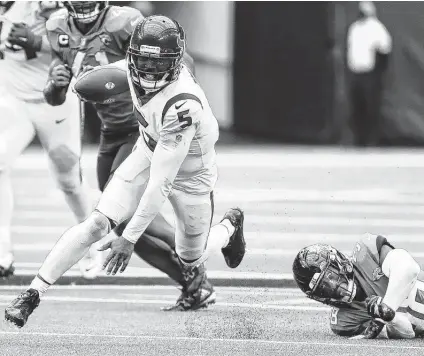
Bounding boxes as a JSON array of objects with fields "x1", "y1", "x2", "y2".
[{"x1": 330, "y1": 234, "x2": 391, "y2": 336}]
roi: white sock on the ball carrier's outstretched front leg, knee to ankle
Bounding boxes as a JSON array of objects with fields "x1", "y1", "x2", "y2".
[{"x1": 38, "y1": 215, "x2": 110, "y2": 284}]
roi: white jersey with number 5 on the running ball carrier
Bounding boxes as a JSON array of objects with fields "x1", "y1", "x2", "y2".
[{"x1": 128, "y1": 66, "x2": 219, "y2": 194}]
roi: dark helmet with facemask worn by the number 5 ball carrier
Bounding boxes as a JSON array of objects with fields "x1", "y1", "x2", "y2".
[{"x1": 127, "y1": 15, "x2": 186, "y2": 91}]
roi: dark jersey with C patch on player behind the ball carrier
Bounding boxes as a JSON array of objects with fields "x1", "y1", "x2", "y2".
[{"x1": 46, "y1": 6, "x2": 142, "y2": 131}]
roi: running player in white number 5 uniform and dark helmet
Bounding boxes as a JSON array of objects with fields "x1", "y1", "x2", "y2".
[{"x1": 5, "y1": 16, "x2": 245, "y2": 327}]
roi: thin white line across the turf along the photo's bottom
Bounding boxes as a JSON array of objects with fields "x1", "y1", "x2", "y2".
[{"x1": 0, "y1": 331, "x2": 424, "y2": 350}]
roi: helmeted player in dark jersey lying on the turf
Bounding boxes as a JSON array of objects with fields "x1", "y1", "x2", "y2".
[{"x1": 293, "y1": 234, "x2": 424, "y2": 339}]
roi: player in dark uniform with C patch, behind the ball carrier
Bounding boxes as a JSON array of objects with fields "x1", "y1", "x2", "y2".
[{"x1": 44, "y1": 1, "x2": 216, "y2": 310}]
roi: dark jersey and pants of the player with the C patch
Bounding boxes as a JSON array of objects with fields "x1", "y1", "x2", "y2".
[{"x1": 46, "y1": 6, "x2": 142, "y2": 190}]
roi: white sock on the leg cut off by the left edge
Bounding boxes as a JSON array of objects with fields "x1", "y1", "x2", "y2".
[{"x1": 0, "y1": 171, "x2": 13, "y2": 268}]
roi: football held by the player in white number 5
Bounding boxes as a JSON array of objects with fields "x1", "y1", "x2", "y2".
[{"x1": 73, "y1": 65, "x2": 130, "y2": 104}]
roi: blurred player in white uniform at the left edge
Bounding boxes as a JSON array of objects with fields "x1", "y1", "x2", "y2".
[{"x1": 0, "y1": 1, "x2": 95, "y2": 277}]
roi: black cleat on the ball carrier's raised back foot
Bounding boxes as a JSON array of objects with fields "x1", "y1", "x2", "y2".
[{"x1": 221, "y1": 208, "x2": 246, "y2": 268}]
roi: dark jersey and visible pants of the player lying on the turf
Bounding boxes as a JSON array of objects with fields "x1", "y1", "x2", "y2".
[{"x1": 330, "y1": 234, "x2": 424, "y2": 336}]
